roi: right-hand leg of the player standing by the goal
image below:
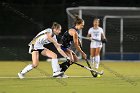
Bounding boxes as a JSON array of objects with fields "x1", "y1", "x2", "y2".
[{"x1": 95, "y1": 47, "x2": 101, "y2": 69}]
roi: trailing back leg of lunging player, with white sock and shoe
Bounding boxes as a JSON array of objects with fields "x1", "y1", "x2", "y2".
[{"x1": 18, "y1": 51, "x2": 39, "y2": 79}]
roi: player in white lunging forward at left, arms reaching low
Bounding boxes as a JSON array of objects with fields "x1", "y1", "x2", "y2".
[{"x1": 18, "y1": 22, "x2": 70, "y2": 79}]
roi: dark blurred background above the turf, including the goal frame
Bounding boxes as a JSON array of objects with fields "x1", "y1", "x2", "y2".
[{"x1": 0, "y1": 0, "x2": 140, "y2": 60}]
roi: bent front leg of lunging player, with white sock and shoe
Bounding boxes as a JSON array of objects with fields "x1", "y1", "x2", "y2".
[{"x1": 41, "y1": 48, "x2": 63, "y2": 77}]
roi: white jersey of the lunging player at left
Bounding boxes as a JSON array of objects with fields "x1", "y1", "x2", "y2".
[{"x1": 29, "y1": 28, "x2": 57, "y2": 53}]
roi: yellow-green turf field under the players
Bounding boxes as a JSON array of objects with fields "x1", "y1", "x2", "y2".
[{"x1": 0, "y1": 61, "x2": 140, "y2": 93}]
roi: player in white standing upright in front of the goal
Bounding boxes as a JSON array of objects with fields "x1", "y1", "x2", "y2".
[{"x1": 87, "y1": 18, "x2": 107, "y2": 69}]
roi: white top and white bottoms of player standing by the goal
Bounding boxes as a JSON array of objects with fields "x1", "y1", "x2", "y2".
[{"x1": 88, "y1": 27, "x2": 103, "y2": 48}]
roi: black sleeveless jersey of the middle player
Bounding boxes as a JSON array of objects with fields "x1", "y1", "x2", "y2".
[{"x1": 62, "y1": 27, "x2": 78, "y2": 48}]
